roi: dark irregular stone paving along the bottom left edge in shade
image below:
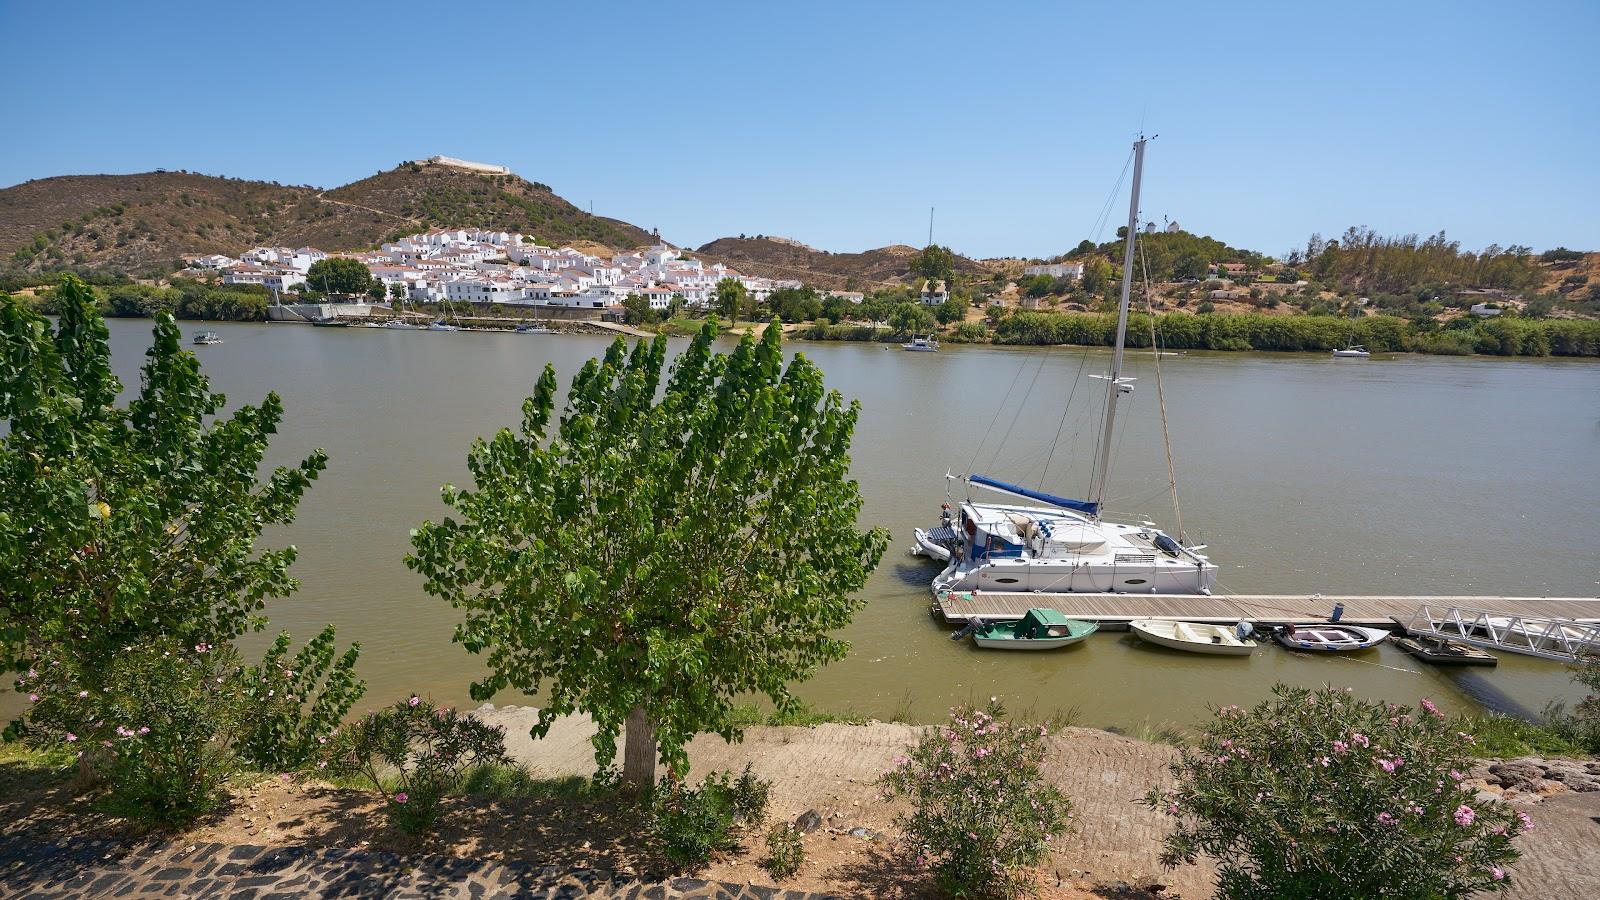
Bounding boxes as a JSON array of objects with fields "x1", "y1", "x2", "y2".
[{"x1": 0, "y1": 838, "x2": 829, "y2": 900}]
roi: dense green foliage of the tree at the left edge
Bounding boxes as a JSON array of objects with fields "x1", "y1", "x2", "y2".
[{"x1": 0, "y1": 275, "x2": 326, "y2": 682}]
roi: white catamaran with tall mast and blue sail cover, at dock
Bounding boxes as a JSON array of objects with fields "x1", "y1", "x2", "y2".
[{"x1": 914, "y1": 136, "x2": 1216, "y2": 594}]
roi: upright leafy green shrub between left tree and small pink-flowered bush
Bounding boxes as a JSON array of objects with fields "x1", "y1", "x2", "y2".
[{"x1": 240, "y1": 625, "x2": 366, "y2": 772}]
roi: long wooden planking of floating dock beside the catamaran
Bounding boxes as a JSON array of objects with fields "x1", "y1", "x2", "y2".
[{"x1": 933, "y1": 591, "x2": 1600, "y2": 629}]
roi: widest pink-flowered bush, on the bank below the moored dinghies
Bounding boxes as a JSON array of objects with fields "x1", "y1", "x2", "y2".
[{"x1": 1144, "y1": 685, "x2": 1533, "y2": 898}]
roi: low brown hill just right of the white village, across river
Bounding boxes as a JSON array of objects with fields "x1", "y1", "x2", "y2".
[{"x1": 696, "y1": 235, "x2": 987, "y2": 290}]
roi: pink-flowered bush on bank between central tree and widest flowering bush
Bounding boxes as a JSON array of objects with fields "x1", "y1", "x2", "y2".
[{"x1": 883, "y1": 698, "x2": 1070, "y2": 897}]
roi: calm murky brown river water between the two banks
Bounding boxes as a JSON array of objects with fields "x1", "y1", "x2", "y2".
[{"x1": 0, "y1": 320, "x2": 1600, "y2": 729}]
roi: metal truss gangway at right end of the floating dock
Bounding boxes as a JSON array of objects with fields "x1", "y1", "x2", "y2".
[{"x1": 1395, "y1": 604, "x2": 1600, "y2": 663}]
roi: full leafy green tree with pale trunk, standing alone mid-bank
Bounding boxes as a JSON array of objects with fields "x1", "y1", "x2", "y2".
[{"x1": 406, "y1": 320, "x2": 888, "y2": 785}]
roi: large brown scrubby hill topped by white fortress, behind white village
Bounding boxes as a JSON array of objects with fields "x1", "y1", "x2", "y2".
[{"x1": 0, "y1": 157, "x2": 656, "y2": 272}]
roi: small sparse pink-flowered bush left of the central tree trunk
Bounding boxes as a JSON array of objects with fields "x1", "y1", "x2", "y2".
[{"x1": 328, "y1": 695, "x2": 509, "y2": 834}]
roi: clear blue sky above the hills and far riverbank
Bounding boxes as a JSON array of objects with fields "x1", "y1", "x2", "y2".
[{"x1": 0, "y1": 0, "x2": 1600, "y2": 256}]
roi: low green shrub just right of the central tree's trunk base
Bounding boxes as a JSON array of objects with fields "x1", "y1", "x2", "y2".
[{"x1": 650, "y1": 765, "x2": 771, "y2": 866}]
